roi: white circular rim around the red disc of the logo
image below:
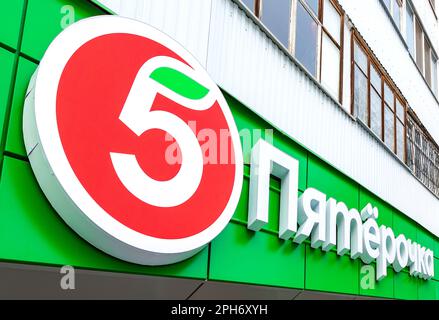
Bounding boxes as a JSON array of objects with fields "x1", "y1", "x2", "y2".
[{"x1": 23, "y1": 16, "x2": 243, "y2": 265}]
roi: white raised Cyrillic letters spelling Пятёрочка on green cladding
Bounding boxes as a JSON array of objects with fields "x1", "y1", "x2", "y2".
[{"x1": 248, "y1": 140, "x2": 434, "y2": 280}]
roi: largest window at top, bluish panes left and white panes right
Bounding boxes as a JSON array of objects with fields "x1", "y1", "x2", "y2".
[{"x1": 243, "y1": 0, "x2": 343, "y2": 102}]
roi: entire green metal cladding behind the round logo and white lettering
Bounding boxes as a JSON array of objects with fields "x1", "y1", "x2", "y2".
[{"x1": 0, "y1": 0, "x2": 439, "y2": 299}]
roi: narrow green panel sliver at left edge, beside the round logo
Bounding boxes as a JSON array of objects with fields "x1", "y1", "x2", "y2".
[{"x1": 0, "y1": 48, "x2": 14, "y2": 152}]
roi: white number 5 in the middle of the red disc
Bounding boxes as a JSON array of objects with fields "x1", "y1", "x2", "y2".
[{"x1": 110, "y1": 56, "x2": 215, "y2": 207}]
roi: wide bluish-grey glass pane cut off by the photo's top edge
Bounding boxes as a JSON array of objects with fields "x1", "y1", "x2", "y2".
[{"x1": 261, "y1": 0, "x2": 291, "y2": 48}]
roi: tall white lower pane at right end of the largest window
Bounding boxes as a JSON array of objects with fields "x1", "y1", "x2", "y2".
[{"x1": 321, "y1": 33, "x2": 340, "y2": 98}]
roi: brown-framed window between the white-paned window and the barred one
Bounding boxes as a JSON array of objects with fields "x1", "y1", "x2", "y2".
[{"x1": 352, "y1": 31, "x2": 406, "y2": 161}]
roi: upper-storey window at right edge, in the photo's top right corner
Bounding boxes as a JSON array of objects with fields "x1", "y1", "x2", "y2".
[{"x1": 406, "y1": 1, "x2": 438, "y2": 96}]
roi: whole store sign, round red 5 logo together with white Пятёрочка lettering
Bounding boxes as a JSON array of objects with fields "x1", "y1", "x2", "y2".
[{"x1": 23, "y1": 16, "x2": 434, "y2": 280}]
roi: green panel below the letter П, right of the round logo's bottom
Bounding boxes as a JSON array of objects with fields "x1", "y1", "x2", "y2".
[{"x1": 209, "y1": 222, "x2": 305, "y2": 288}]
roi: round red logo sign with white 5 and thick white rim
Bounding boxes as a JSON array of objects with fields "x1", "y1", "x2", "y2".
[{"x1": 23, "y1": 16, "x2": 243, "y2": 265}]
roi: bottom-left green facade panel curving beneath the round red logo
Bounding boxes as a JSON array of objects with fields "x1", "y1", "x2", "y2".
[{"x1": 0, "y1": 157, "x2": 208, "y2": 279}]
